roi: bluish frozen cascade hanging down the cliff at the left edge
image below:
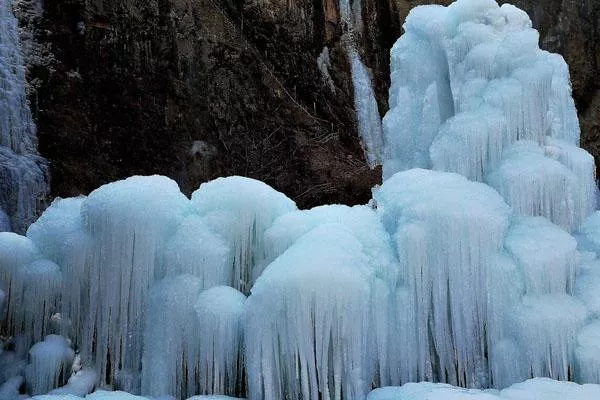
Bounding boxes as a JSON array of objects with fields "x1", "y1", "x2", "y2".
[{"x1": 0, "y1": 0, "x2": 49, "y2": 233}]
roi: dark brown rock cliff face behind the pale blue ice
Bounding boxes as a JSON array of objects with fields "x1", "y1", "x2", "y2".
[{"x1": 21, "y1": 0, "x2": 600, "y2": 207}]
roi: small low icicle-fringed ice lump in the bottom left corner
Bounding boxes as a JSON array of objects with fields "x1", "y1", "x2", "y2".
[{"x1": 25, "y1": 335, "x2": 75, "y2": 395}]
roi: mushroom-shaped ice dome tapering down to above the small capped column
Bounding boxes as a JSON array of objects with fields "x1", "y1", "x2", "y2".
[{"x1": 192, "y1": 176, "x2": 296, "y2": 293}]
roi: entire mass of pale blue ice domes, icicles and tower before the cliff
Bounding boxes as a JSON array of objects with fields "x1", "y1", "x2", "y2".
[{"x1": 5, "y1": 0, "x2": 600, "y2": 400}]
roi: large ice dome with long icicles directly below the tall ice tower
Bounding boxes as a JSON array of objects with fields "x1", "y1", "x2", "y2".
[{"x1": 374, "y1": 169, "x2": 510, "y2": 386}]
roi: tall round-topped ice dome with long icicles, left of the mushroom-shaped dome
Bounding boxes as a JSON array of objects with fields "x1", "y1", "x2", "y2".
[{"x1": 80, "y1": 176, "x2": 189, "y2": 379}]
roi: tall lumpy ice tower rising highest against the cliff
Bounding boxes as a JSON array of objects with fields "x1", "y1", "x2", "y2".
[{"x1": 383, "y1": 0, "x2": 597, "y2": 231}]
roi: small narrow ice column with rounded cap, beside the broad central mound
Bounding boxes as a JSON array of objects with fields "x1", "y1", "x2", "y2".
[{"x1": 194, "y1": 286, "x2": 246, "y2": 394}]
